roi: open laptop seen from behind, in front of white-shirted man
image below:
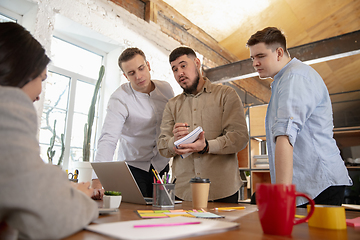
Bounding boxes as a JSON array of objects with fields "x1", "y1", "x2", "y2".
[{"x1": 91, "y1": 161, "x2": 181, "y2": 205}]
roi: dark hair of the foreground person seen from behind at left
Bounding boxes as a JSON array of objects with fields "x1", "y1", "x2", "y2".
[{"x1": 0, "y1": 22, "x2": 50, "y2": 88}]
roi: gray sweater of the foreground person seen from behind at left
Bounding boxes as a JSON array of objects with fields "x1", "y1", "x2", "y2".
[{"x1": 0, "y1": 86, "x2": 98, "y2": 239}]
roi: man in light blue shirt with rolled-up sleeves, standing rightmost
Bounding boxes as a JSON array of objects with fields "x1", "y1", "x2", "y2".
[{"x1": 247, "y1": 27, "x2": 352, "y2": 207}]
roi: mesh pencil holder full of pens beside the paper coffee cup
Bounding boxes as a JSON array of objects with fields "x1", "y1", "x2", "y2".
[{"x1": 153, "y1": 183, "x2": 175, "y2": 208}]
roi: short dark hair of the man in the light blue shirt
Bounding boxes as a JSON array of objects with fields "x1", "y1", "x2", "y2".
[{"x1": 246, "y1": 27, "x2": 288, "y2": 54}]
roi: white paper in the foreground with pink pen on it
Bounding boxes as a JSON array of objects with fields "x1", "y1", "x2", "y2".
[{"x1": 86, "y1": 217, "x2": 239, "y2": 240}]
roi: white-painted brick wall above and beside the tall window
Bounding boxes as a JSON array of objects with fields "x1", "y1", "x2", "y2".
[{"x1": 19, "y1": 0, "x2": 182, "y2": 122}]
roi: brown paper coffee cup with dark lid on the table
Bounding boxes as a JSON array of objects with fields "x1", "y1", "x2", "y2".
[{"x1": 190, "y1": 177, "x2": 210, "y2": 209}]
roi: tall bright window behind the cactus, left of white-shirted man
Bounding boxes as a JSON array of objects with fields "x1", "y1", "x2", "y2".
[{"x1": 39, "y1": 37, "x2": 105, "y2": 166}]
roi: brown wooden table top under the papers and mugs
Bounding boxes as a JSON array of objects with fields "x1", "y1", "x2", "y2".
[{"x1": 65, "y1": 201, "x2": 360, "y2": 240}]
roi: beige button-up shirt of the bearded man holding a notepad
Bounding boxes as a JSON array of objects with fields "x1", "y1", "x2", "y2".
[{"x1": 158, "y1": 79, "x2": 249, "y2": 201}]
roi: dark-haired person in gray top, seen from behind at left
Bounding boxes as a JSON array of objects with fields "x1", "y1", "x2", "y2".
[{"x1": 0, "y1": 23, "x2": 98, "y2": 239}]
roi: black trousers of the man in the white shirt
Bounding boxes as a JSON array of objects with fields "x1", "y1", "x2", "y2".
[{"x1": 128, "y1": 164, "x2": 169, "y2": 197}]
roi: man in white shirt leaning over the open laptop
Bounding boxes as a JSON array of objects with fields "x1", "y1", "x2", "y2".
[{"x1": 92, "y1": 48, "x2": 174, "y2": 198}]
